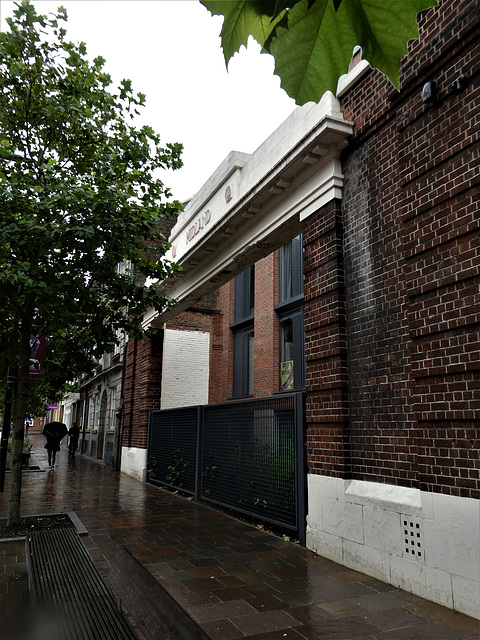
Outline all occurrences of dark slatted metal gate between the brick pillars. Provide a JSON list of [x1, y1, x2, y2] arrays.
[[147, 393, 306, 544]]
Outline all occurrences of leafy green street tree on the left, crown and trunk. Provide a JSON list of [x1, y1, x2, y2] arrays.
[[0, 0, 182, 521]]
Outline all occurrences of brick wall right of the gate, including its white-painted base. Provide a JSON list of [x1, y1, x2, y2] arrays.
[[304, 2, 480, 617]]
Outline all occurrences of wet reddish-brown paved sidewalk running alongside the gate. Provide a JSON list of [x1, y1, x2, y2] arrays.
[[0, 435, 480, 640]]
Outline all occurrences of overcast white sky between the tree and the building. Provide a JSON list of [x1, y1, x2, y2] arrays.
[[0, 0, 295, 200]]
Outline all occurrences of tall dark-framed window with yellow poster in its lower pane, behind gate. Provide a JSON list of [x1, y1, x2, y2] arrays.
[[275, 235, 305, 391]]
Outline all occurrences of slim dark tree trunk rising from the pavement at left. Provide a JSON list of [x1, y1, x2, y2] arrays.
[[7, 322, 30, 525]]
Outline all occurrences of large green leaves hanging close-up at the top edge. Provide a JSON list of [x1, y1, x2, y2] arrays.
[[201, 0, 436, 105]]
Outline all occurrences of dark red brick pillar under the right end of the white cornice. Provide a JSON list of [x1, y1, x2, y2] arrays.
[[303, 201, 350, 478]]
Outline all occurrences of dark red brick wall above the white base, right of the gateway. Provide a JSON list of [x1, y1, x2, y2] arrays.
[[320, 0, 480, 497]]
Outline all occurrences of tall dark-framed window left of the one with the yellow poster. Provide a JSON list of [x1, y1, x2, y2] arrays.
[[230, 266, 255, 398]]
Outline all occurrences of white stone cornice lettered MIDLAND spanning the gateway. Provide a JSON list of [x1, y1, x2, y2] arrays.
[[143, 92, 352, 328]]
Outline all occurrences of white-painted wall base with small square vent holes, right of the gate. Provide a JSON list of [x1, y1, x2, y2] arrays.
[[307, 475, 480, 618]]
